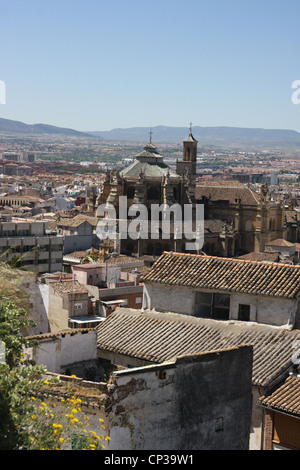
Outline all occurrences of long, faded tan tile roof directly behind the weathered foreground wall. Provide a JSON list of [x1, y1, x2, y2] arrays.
[[97, 308, 300, 387]]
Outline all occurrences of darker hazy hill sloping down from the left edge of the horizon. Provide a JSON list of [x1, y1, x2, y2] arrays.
[[0, 118, 91, 137]]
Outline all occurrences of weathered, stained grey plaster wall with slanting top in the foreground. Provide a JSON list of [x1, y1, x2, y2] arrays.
[[109, 346, 252, 450]]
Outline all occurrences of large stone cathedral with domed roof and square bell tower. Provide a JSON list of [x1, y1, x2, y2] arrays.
[[90, 127, 285, 257]]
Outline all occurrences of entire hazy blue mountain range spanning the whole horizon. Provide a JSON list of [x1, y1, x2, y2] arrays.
[[0, 118, 300, 151]]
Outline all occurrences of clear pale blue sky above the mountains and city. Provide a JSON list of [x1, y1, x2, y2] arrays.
[[0, 0, 300, 131]]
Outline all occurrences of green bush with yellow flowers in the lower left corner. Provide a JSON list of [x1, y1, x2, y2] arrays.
[[0, 302, 109, 450]]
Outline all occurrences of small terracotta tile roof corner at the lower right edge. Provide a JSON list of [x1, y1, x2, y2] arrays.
[[259, 375, 300, 416]]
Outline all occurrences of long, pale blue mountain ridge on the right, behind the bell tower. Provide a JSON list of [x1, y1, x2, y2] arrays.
[[91, 126, 300, 150]]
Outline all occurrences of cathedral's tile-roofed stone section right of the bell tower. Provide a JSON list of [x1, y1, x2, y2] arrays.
[[196, 181, 286, 256]]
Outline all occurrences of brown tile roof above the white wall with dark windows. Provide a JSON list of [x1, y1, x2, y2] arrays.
[[143, 252, 300, 298]]
